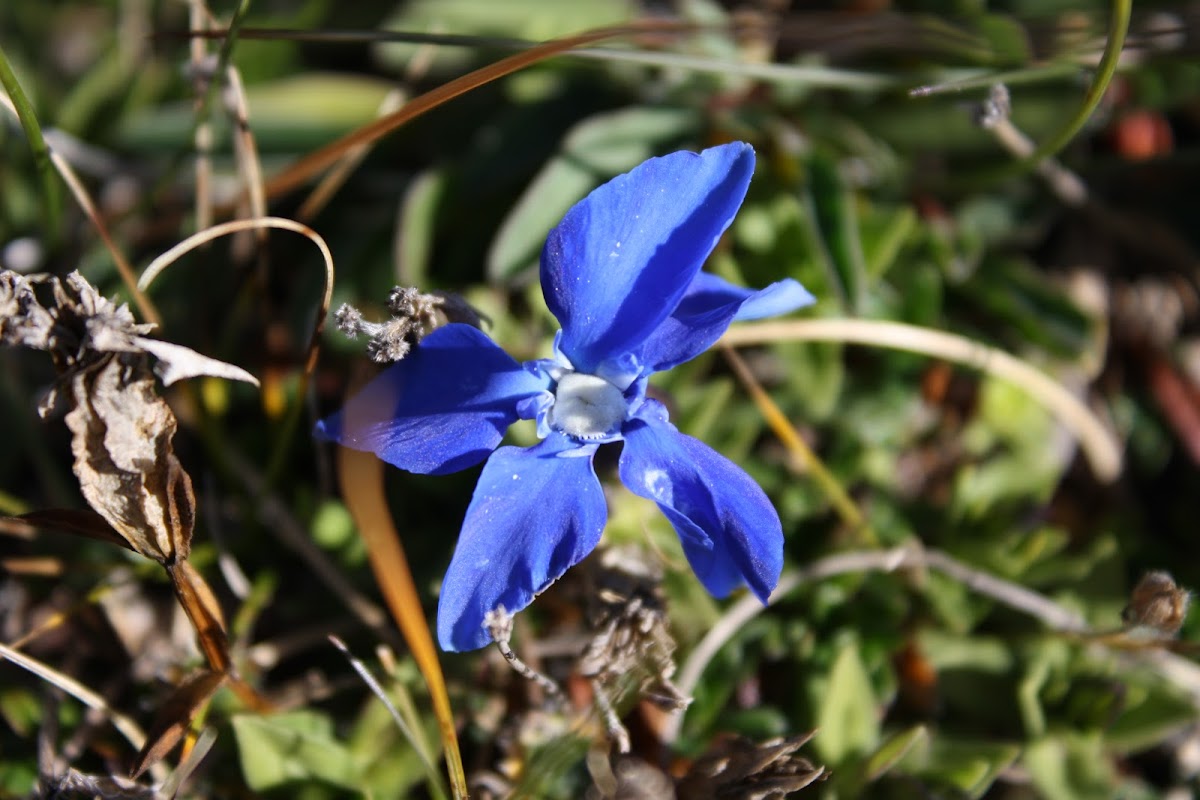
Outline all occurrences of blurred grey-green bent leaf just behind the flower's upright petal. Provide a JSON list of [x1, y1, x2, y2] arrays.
[[487, 107, 698, 282]]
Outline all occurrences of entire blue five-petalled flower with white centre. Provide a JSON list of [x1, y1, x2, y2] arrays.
[[316, 143, 812, 650]]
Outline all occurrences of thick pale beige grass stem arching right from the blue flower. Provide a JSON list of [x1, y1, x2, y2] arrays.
[[720, 319, 1121, 483]]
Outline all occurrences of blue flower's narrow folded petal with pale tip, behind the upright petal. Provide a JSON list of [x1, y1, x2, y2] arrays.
[[642, 272, 815, 372]]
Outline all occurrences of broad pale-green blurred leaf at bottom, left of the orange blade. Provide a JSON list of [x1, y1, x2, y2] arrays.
[[232, 711, 362, 792]]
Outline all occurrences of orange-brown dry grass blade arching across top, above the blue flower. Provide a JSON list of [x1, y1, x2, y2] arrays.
[[266, 22, 694, 197]]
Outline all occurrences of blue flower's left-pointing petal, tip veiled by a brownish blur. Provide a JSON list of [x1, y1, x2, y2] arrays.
[[313, 324, 550, 475]]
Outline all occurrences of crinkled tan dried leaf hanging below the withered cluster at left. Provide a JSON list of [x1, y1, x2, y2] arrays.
[[66, 355, 196, 565]]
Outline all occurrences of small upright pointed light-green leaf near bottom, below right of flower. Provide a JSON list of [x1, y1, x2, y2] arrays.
[[814, 644, 880, 764]]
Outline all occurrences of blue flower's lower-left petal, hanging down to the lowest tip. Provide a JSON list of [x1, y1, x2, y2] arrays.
[[438, 433, 607, 650]]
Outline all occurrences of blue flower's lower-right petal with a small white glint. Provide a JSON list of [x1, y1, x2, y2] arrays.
[[620, 401, 784, 602]]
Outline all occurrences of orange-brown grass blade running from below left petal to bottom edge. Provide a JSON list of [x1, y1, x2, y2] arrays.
[[337, 447, 467, 798]]
